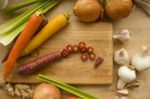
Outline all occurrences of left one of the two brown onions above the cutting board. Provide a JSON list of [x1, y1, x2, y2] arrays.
[[74, 0, 104, 22]]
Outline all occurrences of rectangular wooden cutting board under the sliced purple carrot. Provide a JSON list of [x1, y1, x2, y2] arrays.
[[0, 0, 113, 84]]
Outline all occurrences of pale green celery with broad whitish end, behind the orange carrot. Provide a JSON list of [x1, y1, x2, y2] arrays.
[[0, 0, 61, 46]]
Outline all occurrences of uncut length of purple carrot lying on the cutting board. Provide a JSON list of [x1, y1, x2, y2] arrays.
[[18, 51, 63, 75]]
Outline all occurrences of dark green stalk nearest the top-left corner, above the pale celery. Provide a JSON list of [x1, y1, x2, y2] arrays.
[[4, 0, 44, 15]]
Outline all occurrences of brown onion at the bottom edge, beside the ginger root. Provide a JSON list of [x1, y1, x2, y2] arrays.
[[33, 83, 62, 99]]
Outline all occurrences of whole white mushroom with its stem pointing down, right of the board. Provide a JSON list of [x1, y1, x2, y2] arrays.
[[117, 66, 136, 89]]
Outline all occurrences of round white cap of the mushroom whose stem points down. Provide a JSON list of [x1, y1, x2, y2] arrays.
[[118, 66, 136, 83]]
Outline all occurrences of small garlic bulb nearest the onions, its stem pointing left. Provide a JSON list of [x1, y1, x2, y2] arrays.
[[113, 29, 131, 43]]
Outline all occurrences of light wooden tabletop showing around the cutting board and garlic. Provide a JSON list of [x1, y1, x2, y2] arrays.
[[0, 0, 150, 99]]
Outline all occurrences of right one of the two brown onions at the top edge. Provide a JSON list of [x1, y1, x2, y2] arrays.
[[105, 0, 133, 20]]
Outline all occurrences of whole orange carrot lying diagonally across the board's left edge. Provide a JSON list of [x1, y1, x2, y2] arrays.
[[3, 12, 43, 79]]
